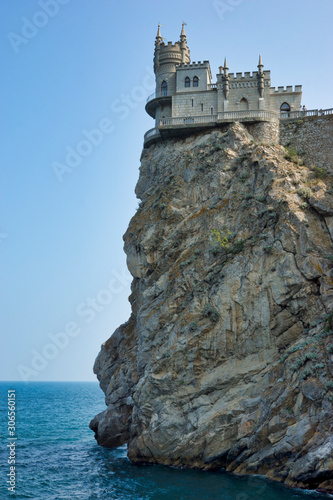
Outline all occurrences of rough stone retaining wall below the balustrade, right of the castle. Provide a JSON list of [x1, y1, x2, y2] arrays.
[[280, 115, 333, 174]]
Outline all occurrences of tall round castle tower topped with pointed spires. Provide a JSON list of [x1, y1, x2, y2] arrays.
[[146, 23, 191, 123]]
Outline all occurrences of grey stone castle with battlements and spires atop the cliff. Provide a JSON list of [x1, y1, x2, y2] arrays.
[[144, 23, 302, 147]]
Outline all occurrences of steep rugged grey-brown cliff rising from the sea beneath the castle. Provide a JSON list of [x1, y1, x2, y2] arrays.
[[90, 124, 333, 491]]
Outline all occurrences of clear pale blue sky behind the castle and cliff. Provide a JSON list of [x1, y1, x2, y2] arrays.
[[0, 0, 333, 381]]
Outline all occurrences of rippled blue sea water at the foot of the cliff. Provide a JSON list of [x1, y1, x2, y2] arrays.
[[0, 382, 329, 500]]
